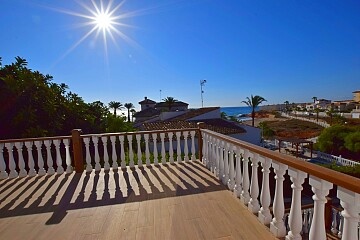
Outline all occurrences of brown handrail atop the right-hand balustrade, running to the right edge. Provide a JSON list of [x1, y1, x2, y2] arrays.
[[201, 129, 360, 193]]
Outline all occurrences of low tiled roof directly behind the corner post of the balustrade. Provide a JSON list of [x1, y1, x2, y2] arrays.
[[140, 118, 246, 134]]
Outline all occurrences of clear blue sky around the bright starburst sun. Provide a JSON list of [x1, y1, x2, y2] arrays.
[[0, 0, 360, 108]]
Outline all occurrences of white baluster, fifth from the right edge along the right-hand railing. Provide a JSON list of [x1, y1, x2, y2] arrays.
[[258, 157, 272, 225]]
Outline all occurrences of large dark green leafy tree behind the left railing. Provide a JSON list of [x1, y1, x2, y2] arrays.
[[0, 57, 132, 139]]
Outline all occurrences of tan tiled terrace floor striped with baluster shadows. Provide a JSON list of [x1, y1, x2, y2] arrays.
[[0, 162, 274, 240]]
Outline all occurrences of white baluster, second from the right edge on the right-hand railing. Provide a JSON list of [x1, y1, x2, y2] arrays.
[[309, 176, 334, 239]]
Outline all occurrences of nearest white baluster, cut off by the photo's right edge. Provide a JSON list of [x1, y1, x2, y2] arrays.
[[337, 187, 360, 240]]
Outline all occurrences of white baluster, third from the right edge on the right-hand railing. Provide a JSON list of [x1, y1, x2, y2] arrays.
[[286, 168, 307, 240]]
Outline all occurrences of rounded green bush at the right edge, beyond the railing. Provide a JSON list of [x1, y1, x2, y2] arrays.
[[316, 125, 360, 159]]
